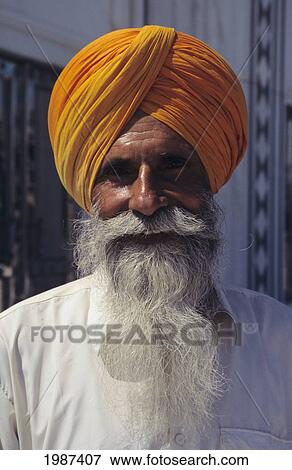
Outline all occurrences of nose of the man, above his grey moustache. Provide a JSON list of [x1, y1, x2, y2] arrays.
[[129, 164, 168, 216]]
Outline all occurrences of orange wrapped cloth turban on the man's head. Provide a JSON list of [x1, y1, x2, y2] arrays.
[[48, 25, 247, 212]]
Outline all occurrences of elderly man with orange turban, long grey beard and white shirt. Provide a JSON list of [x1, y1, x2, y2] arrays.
[[0, 26, 292, 449]]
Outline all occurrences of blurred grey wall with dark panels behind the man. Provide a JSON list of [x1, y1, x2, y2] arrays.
[[0, 0, 292, 310]]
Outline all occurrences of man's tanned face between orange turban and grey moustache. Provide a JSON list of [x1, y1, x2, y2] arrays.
[[92, 110, 209, 219]]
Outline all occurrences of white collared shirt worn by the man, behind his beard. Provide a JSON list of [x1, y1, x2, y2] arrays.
[[0, 277, 292, 449]]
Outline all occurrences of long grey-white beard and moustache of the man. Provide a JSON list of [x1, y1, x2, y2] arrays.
[[74, 194, 225, 449]]
